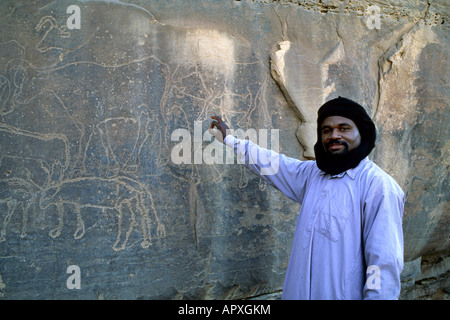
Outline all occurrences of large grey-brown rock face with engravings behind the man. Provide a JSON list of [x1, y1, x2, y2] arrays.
[[0, 0, 450, 299]]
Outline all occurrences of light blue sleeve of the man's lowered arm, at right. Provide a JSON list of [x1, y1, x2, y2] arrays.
[[363, 176, 405, 300]]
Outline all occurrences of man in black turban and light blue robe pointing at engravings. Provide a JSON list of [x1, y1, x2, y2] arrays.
[[210, 97, 405, 299]]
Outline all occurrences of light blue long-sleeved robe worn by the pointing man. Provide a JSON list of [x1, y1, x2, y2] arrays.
[[225, 135, 405, 300]]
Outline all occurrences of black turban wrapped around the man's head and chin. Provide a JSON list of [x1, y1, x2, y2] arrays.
[[314, 97, 377, 175]]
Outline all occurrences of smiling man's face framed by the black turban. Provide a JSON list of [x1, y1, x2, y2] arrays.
[[321, 116, 361, 155]]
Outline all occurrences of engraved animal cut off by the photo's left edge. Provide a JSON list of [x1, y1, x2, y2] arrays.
[[0, 123, 69, 242]]
